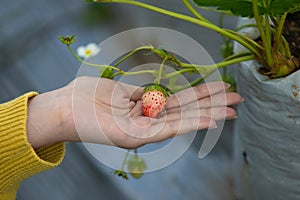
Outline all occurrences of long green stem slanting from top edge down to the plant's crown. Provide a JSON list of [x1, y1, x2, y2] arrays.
[[96, 0, 260, 56]]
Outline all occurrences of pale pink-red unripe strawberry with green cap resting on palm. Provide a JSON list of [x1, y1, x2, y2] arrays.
[[142, 84, 168, 118]]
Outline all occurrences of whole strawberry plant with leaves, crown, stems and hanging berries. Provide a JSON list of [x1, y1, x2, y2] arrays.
[[60, 0, 300, 184]]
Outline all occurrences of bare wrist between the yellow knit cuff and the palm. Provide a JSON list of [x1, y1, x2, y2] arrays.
[[27, 87, 72, 149]]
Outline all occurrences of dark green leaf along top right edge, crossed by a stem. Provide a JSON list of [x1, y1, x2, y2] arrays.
[[193, 0, 300, 17]]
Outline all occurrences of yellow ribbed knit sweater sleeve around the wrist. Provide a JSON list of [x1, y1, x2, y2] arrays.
[[0, 92, 65, 200]]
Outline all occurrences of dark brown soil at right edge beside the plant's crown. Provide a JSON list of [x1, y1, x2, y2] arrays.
[[283, 12, 300, 63]]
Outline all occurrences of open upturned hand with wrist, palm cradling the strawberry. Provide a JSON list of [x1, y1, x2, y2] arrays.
[[29, 77, 242, 148]]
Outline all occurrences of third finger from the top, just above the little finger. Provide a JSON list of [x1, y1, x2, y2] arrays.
[[162, 107, 237, 121]]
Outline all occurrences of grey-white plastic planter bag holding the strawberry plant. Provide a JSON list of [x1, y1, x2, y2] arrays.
[[234, 61, 300, 200]]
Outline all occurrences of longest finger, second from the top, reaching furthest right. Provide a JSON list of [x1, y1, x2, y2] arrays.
[[167, 93, 243, 113]]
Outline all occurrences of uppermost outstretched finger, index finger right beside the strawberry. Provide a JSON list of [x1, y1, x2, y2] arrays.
[[166, 82, 229, 109]]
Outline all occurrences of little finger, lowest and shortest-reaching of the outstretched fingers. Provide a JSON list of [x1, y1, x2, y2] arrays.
[[146, 118, 217, 143]]
